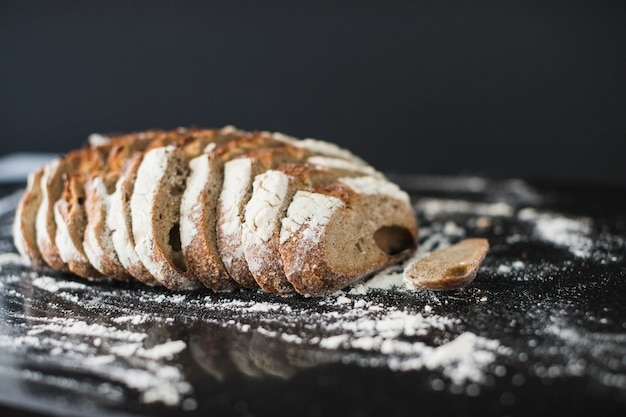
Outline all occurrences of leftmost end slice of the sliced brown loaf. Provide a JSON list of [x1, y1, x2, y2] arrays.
[[13, 168, 46, 268]]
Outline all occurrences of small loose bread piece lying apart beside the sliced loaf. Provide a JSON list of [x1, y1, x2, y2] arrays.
[[404, 238, 489, 290]]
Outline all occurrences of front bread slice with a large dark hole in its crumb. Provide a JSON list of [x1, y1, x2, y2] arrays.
[[279, 176, 417, 296]]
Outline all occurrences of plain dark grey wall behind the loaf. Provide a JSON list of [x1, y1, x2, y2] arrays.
[[0, 0, 626, 184]]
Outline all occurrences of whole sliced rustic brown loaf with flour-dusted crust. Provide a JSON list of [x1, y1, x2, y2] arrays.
[[14, 127, 417, 296]]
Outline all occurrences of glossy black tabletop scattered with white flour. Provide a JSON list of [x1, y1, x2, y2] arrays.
[[0, 176, 626, 416]]
